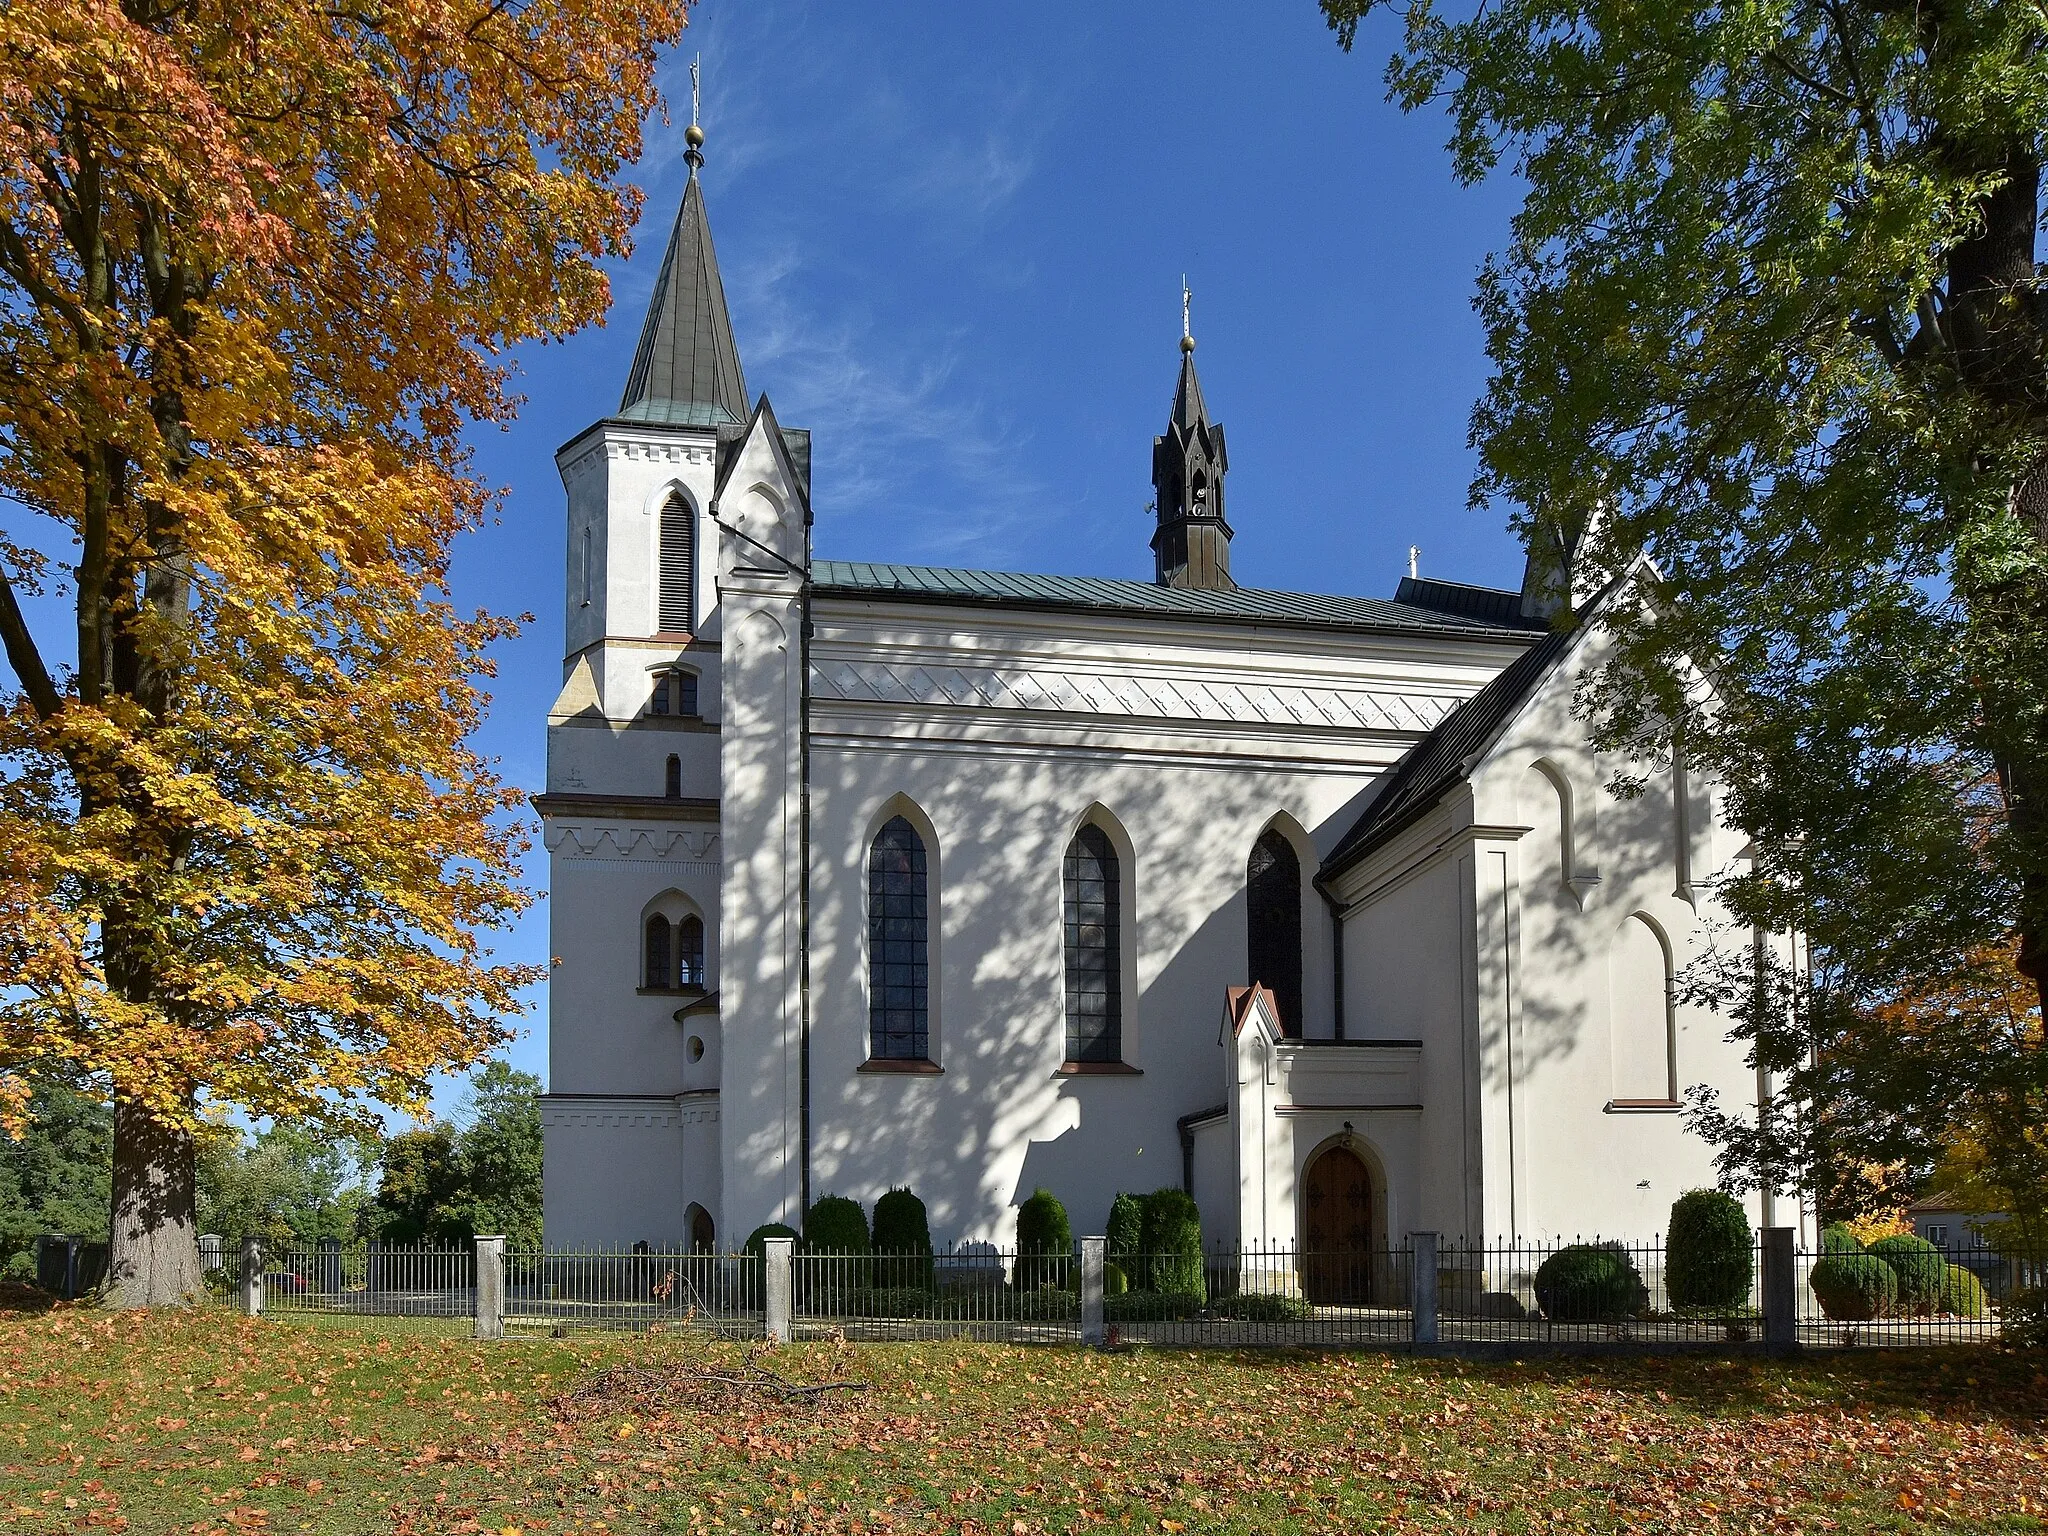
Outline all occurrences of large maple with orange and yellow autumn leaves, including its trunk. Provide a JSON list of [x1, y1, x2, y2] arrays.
[[0, 0, 688, 1305]]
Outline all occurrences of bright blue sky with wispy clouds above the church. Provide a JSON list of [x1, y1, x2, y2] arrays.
[[442, 0, 1522, 1102]]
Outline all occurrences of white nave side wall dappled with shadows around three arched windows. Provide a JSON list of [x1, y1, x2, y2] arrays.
[[790, 598, 1520, 1241]]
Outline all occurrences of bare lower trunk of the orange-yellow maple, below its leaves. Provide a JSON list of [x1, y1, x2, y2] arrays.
[[106, 1098, 205, 1307]]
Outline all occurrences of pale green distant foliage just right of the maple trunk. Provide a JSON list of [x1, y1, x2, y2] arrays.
[[197, 1124, 369, 1247]]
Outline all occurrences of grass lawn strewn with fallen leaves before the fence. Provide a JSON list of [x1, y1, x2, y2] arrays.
[[0, 1309, 2048, 1536]]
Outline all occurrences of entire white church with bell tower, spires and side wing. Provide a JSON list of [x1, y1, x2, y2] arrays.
[[537, 129, 1763, 1249]]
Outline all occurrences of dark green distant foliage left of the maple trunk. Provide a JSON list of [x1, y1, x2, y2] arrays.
[[0, 1075, 113, 1278]]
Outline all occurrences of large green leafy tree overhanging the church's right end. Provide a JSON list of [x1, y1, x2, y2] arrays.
[[1321, 0, 2048, 1212]]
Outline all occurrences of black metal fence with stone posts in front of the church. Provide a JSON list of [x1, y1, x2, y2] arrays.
[[229, 1235, 2048, 1350]]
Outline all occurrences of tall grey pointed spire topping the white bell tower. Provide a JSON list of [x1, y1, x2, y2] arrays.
[[618, 87, 748, 426]]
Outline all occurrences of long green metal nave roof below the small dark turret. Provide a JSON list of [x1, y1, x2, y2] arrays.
[[811, 559, 1536, 639]]
